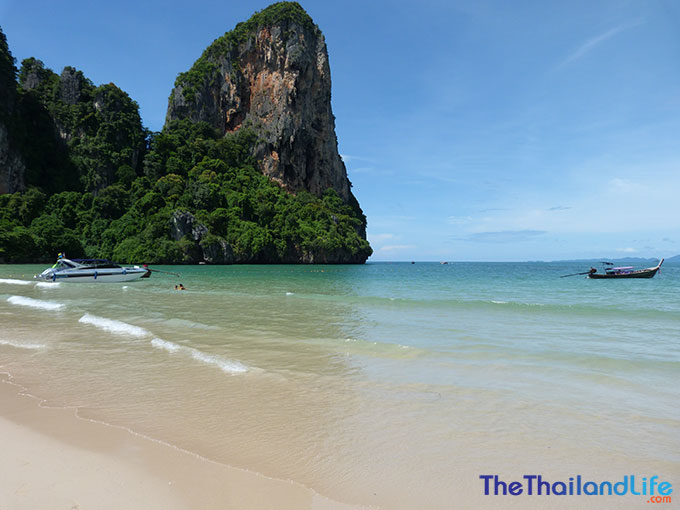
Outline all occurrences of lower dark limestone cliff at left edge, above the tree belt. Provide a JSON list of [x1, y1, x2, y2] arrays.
[[0, 30, 146, 194]]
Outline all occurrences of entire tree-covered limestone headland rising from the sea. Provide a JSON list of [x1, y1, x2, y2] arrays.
[[0, 2, 372, 264]]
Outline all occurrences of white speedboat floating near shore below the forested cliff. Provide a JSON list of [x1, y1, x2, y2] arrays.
[[34, 257, 151, 282]]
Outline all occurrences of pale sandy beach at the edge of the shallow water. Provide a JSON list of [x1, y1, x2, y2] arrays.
[[0, 372, 361, 510]]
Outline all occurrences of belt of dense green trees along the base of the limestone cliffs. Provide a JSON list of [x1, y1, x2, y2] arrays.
[[0, 120, 370, 263]]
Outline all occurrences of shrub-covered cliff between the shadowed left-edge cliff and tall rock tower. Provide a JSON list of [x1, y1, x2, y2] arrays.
[[19, 58, 147, 191]]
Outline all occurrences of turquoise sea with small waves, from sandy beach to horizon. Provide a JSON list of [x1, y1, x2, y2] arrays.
[[0, 263, 680, 508]]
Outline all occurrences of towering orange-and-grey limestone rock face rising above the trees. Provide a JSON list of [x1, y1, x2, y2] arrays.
[[166, 2, 355, 202]]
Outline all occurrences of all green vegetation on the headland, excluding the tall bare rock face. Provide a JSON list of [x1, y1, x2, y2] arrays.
[[0, 17, 371, 263]]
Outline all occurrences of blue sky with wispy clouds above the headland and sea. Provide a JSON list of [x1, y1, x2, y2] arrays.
[[0, 0, 680, 261]]
